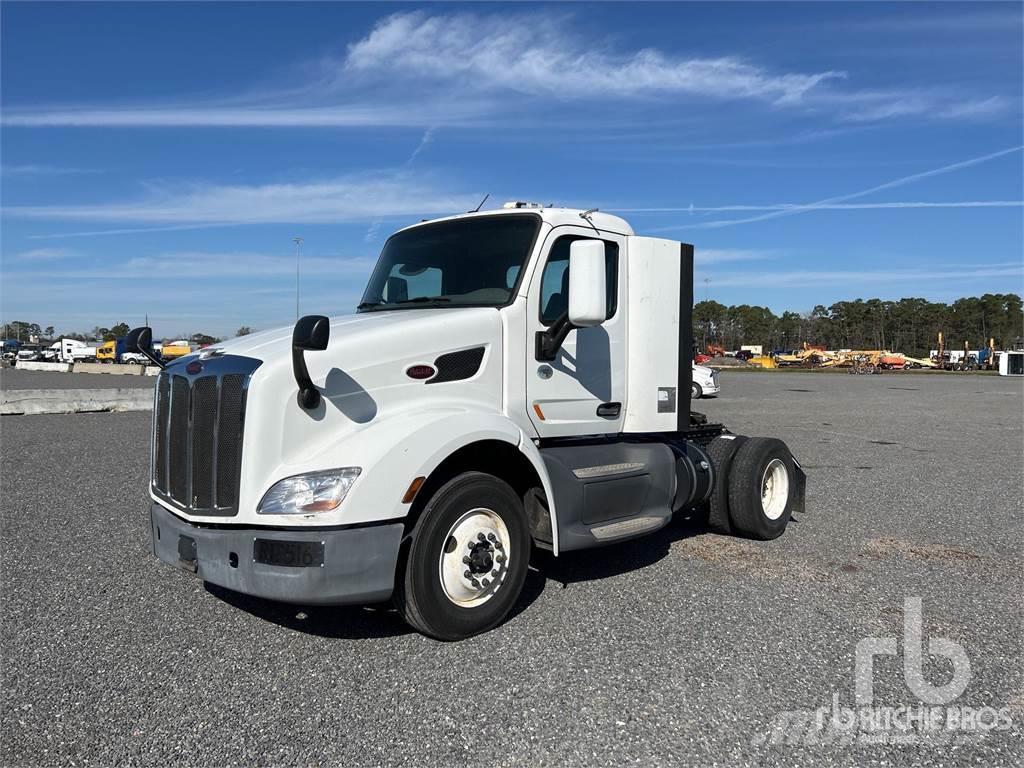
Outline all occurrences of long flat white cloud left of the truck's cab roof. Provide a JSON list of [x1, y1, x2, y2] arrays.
[[4, 172, 479, 225]]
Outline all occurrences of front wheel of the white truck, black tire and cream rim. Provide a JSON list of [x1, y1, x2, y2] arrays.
[[394, 472, 530, 640]]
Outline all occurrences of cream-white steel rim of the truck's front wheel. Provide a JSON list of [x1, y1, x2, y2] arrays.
[[438, 507, 513, 608]]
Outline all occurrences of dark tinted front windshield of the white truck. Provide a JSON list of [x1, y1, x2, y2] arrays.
[[358, 214, 541, 311]]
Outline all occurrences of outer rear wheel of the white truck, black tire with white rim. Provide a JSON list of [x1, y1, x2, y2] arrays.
[[729, 437, 797, 540]]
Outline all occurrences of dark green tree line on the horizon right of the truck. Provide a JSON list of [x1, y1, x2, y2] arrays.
[[693, 293, 1024, 357]]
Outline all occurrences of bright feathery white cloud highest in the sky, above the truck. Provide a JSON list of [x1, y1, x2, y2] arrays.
[[344, 11, 845, 103]]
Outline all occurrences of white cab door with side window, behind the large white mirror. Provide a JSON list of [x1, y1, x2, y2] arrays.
[[526, 226, 626, 437]]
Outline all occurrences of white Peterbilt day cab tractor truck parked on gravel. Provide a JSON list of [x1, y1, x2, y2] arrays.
[[129, 203, 805, 640]]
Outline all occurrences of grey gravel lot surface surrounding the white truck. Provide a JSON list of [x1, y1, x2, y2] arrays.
[[0, 372, 1024, 766]]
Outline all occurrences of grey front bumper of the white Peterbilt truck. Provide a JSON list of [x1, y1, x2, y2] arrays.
[[150, 502, 403, 605]]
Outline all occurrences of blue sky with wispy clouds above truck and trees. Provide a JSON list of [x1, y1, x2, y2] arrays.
[[0, 3, 1024, 335]]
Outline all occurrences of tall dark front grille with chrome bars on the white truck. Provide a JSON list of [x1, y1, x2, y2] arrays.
[[152, 355, 260, 517]]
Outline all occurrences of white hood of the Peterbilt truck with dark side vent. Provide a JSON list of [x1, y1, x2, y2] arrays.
[[209, 307, 503, 506]]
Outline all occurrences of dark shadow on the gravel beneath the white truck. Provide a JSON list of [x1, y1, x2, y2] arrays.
[[204, 514, 720, 640]]
